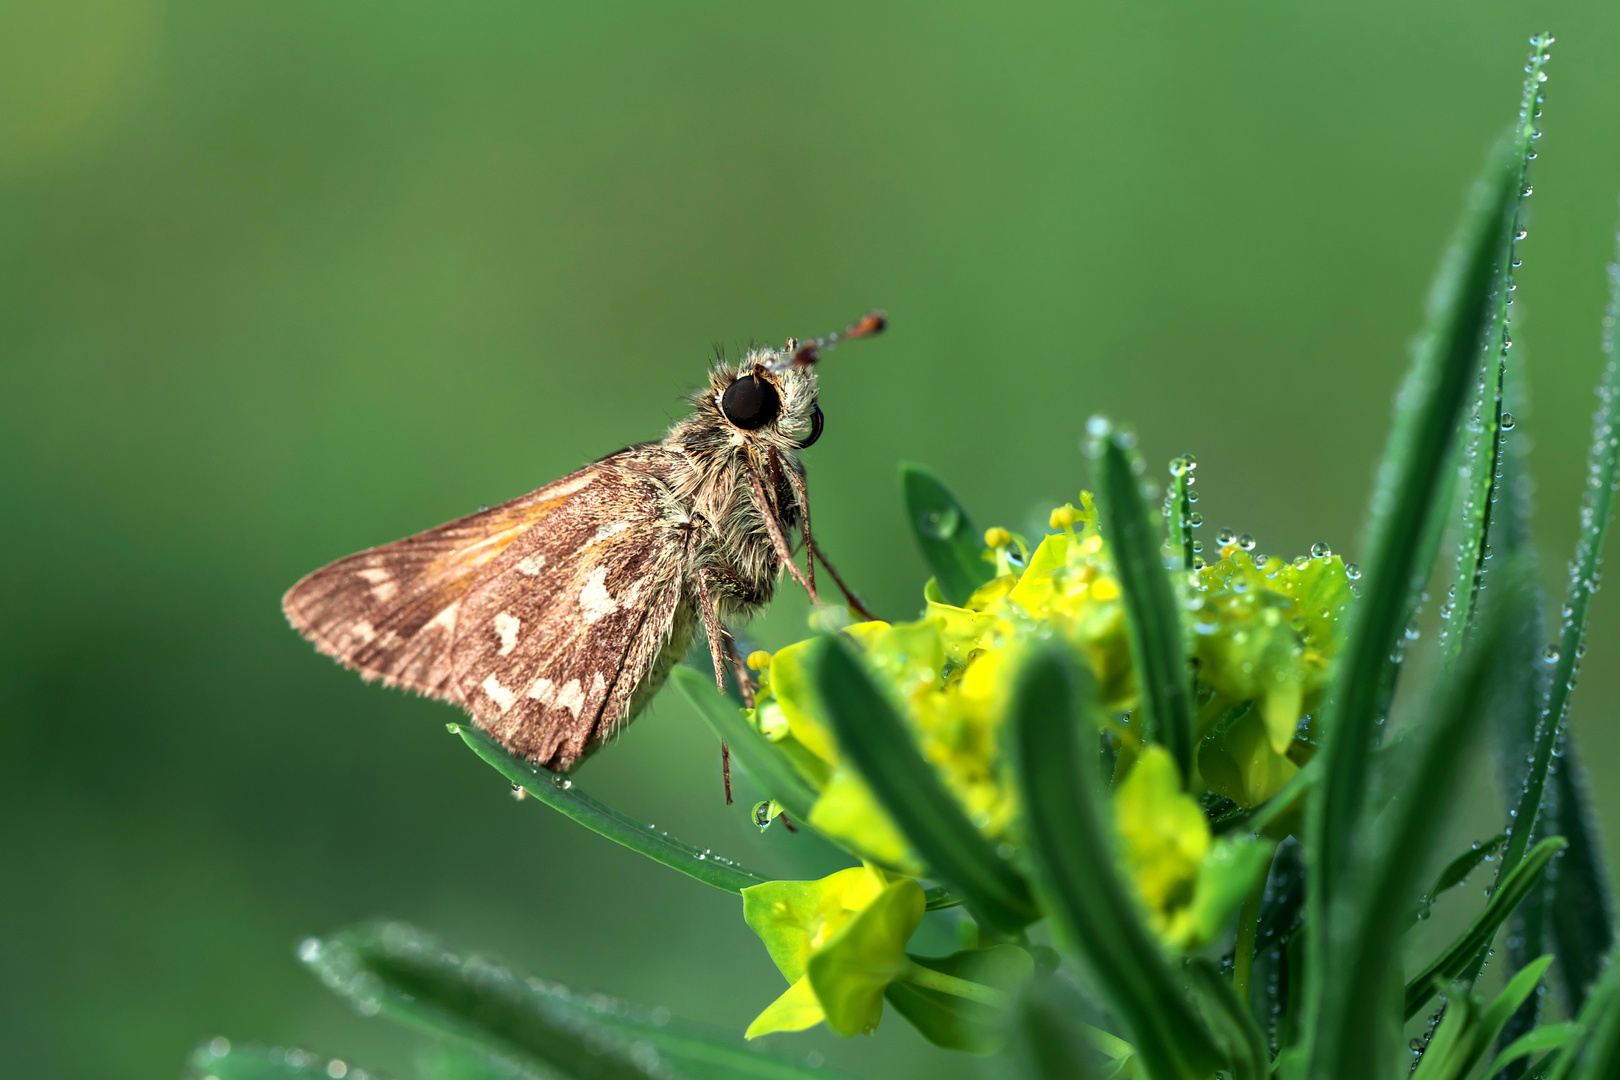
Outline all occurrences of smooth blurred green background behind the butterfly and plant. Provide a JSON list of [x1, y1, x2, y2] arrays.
[[0, 0, 1620, 1080]]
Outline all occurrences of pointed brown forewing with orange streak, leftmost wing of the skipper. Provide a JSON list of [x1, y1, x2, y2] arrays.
[[282, 466, 598, 701]]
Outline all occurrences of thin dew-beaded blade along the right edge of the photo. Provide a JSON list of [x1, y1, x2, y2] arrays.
[[1497, 215, 1620, 984]]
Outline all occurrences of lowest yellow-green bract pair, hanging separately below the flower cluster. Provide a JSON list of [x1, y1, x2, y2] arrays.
[[742, 866, 925, 1038]]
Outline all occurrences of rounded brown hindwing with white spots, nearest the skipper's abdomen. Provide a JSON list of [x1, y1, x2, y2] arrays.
[[452, 450, 690, 771]]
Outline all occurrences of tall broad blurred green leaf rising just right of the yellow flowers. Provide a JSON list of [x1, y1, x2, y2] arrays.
[[1307, 131, 1520, 1049]]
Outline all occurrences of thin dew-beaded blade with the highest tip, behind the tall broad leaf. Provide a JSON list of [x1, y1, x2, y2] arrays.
[[1440, 34, 1552, 670]]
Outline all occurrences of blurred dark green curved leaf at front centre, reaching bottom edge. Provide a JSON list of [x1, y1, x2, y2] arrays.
[[1011, 648, 1225, 1080]]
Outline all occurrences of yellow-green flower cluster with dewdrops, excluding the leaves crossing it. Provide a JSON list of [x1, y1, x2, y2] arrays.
[[747, 492, 1351, 1035]]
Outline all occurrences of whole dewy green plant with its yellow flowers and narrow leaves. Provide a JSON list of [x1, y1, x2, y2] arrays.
[[202, 37, 1620, 1080]]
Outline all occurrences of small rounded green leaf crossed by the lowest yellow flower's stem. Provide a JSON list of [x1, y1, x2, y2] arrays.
[[886, 946, 1035, 1054]]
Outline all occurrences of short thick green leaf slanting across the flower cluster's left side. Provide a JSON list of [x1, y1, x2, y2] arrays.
[[808, 638, 1038, 934]]
